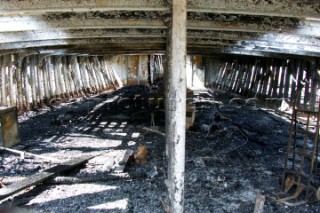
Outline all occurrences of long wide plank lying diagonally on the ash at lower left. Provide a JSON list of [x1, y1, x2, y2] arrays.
[[0, 155, 95, 199]]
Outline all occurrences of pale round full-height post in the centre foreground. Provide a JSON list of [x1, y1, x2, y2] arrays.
[[166, 0, 187, 213]]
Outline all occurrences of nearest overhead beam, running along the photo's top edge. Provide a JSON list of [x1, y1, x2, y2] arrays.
[[0, 0, 320, 18]]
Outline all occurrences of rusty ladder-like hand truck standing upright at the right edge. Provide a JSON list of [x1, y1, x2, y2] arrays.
[[278, 79, 320, 206]]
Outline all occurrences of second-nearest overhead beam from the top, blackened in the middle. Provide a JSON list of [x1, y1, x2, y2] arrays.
[[0, 11, 320, 35]]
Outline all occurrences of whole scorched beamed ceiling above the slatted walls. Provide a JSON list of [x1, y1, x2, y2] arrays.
[[0, 0, 320, 57]]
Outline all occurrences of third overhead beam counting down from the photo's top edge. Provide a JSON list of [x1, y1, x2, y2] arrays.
[[0, 29, 320, 48]]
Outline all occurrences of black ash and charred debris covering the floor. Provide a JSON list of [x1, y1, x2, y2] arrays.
[[0, 86, 320, 213]]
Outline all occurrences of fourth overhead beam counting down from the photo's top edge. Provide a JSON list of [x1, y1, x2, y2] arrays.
[[0, 36, 320, 57]]
